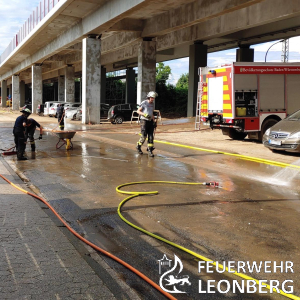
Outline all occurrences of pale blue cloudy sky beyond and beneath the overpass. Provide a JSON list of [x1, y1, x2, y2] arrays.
[[0, 0, 300, 85]]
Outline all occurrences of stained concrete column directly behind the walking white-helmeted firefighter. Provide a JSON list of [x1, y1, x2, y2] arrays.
[[137, 41, 156, 104]]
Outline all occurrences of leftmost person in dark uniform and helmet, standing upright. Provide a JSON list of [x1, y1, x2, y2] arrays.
[[13, 108, 31, 160]]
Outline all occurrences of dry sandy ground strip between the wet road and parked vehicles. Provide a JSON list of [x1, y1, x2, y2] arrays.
[[0, 108, 300, 164]]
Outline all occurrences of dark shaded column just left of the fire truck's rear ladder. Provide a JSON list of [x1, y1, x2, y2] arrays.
[[187, 42, 207, 117]]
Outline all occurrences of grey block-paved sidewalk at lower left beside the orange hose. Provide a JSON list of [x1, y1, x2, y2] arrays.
[[0, 157, 138, 300]]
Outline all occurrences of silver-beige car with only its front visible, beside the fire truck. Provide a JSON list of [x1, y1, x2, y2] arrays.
[[262, 110, 300, 152]]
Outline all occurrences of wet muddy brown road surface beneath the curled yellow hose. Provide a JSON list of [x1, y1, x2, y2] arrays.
[[0, 118, 300, 299]]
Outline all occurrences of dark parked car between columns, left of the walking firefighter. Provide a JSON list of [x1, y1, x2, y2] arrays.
[[107, 103, 139, 124]]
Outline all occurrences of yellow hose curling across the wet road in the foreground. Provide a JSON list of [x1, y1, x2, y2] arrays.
[[116, 181, 300, 300]]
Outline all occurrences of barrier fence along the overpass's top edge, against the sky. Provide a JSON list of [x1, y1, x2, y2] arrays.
[[0, 0, 59, 66]]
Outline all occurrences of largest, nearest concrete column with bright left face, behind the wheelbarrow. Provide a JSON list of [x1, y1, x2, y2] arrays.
[[82, 38, 101, 124]]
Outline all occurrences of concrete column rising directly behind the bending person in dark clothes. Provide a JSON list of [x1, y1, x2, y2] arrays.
[[31, 66, 43, 112]]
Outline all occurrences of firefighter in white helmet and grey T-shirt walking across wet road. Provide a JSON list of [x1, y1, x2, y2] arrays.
[[136, 91, 158, 157]]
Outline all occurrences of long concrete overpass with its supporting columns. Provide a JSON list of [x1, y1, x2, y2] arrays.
[[0, 0, 300, 123]]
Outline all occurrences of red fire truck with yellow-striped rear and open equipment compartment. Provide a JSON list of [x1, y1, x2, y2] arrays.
[[196, 62, 300, 141]]
